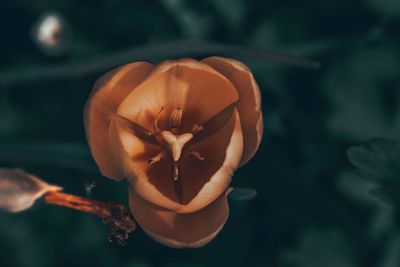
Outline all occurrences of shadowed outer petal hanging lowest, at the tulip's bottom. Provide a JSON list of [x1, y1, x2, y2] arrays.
[[129, 186, 230, 248]]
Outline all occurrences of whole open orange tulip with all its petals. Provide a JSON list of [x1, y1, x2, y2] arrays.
[[85, 57, 263, 247]]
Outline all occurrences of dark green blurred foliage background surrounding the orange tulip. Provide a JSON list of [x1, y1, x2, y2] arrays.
[[0, 0, 400, 267]]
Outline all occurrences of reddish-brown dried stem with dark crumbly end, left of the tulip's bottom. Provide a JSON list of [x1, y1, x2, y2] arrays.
[[43, 192, 136, 246]]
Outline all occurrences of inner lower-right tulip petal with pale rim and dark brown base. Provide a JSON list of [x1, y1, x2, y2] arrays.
[[177, 109, 243, 213]]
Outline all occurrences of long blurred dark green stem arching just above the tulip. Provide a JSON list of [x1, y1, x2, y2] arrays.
[[0, 40, 319, 86]]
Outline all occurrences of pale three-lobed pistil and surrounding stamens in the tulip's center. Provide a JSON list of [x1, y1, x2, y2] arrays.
[[148, 107, 205, 181]]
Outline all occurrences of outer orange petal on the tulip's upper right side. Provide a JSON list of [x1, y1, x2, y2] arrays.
[[202, 57, 263, 165]]
